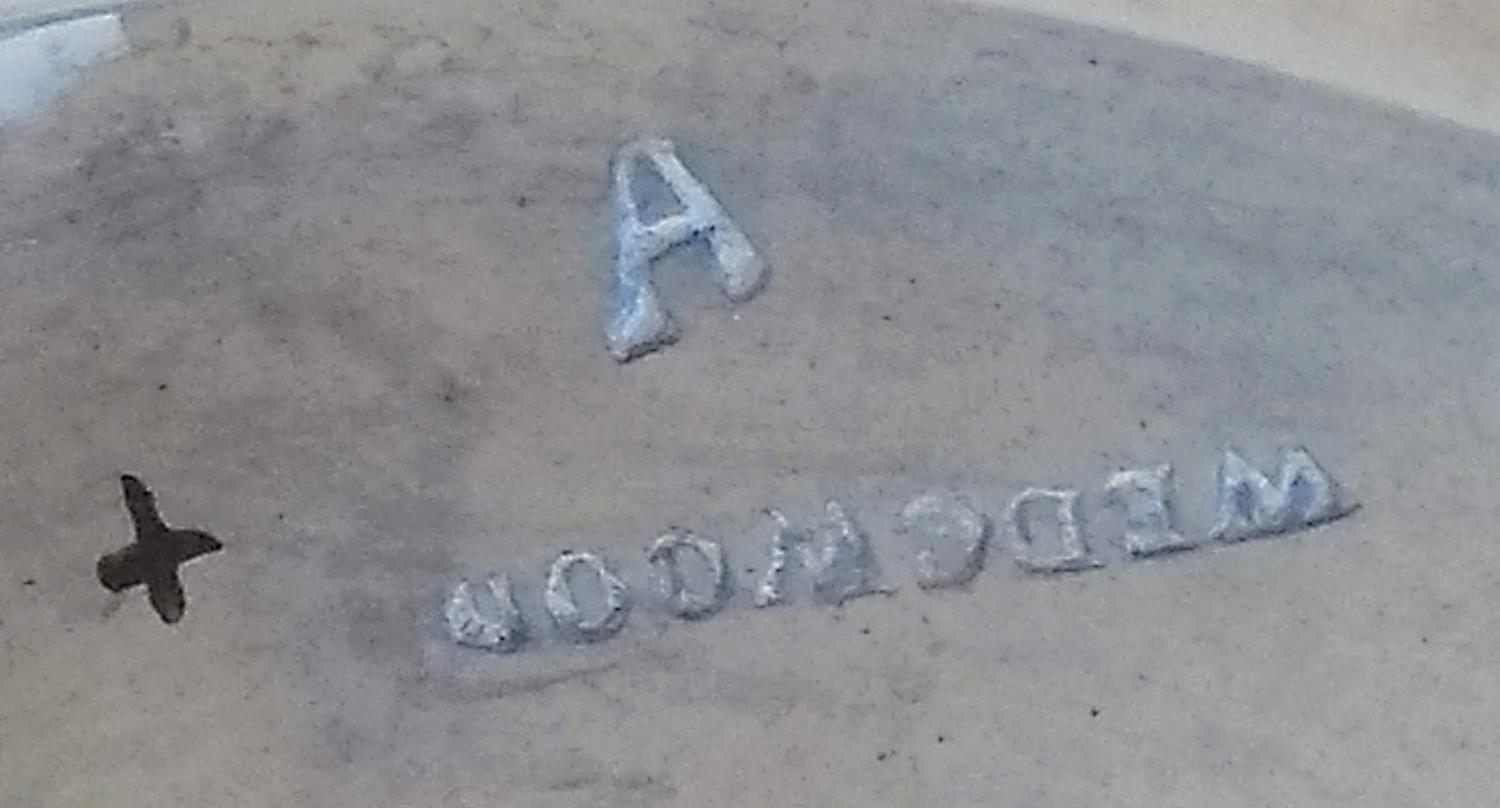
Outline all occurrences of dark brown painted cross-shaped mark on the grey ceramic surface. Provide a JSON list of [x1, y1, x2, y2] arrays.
[[99, 474, 224, 624]]
